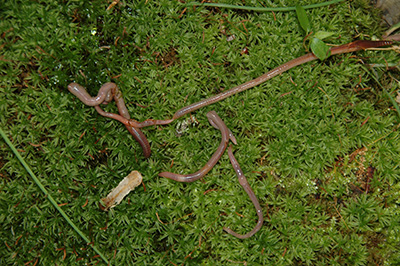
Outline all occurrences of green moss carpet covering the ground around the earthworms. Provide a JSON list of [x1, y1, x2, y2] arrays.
[[0, 0, 400, 265]]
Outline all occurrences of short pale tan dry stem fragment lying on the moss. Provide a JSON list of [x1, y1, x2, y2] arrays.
[[101, 171, 143, 211]]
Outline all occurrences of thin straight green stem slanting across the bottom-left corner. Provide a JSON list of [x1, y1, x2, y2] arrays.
[[0, 128, 110, 265]]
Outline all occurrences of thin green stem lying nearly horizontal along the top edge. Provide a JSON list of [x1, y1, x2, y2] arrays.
[[185, 0, 344, 12]]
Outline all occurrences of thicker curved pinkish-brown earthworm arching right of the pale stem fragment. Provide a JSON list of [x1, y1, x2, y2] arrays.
[[158, 111, 237, 182]]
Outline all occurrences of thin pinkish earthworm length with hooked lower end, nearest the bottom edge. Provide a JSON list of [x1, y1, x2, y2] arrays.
[[224, 145, 264, 239]]
